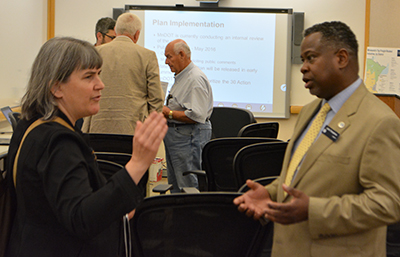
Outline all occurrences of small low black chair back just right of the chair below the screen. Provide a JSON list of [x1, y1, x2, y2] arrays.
[[238, 122, 279, 138]]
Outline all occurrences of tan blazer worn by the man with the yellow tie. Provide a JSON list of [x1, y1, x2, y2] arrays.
[[267, 85, 400, 257]]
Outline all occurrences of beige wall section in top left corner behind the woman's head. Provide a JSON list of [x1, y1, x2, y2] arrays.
[[0, 0, 47, 107]]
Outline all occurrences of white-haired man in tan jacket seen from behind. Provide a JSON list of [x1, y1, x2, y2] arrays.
[[82, 13, 164, 135]]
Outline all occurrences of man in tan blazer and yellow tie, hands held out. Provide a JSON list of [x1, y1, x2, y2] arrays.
[[234, 22, 400, 257]]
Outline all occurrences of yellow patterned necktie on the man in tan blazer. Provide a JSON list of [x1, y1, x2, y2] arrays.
[[285, 103, 331, 186]]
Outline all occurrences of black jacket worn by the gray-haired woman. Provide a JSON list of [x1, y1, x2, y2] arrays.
[[8, 112, 143, 257]]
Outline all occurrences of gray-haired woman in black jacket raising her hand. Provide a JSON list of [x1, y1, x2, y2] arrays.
[[7, 37, 168, 257]]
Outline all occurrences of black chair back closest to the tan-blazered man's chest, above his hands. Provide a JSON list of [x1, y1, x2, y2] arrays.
[[233, 142, 288, 186]]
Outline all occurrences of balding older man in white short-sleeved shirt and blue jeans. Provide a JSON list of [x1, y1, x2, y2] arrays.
[[162, 39, 214, 193]]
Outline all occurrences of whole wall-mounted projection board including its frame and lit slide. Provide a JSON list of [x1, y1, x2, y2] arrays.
[[130, 5, 292, 118]]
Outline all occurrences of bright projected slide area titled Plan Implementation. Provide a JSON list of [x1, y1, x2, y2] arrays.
[[144, 11, 275, 112]]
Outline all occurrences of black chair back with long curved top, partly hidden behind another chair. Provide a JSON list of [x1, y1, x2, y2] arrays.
[[202, 137, 282, 192]]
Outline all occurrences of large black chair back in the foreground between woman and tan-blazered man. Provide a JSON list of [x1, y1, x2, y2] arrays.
[[132, 193, 272, 257]]
